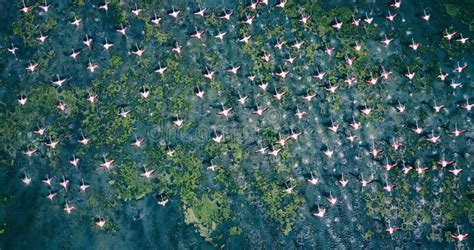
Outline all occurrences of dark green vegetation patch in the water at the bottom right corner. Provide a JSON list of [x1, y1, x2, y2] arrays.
[[365, 173, 474, 241]]
